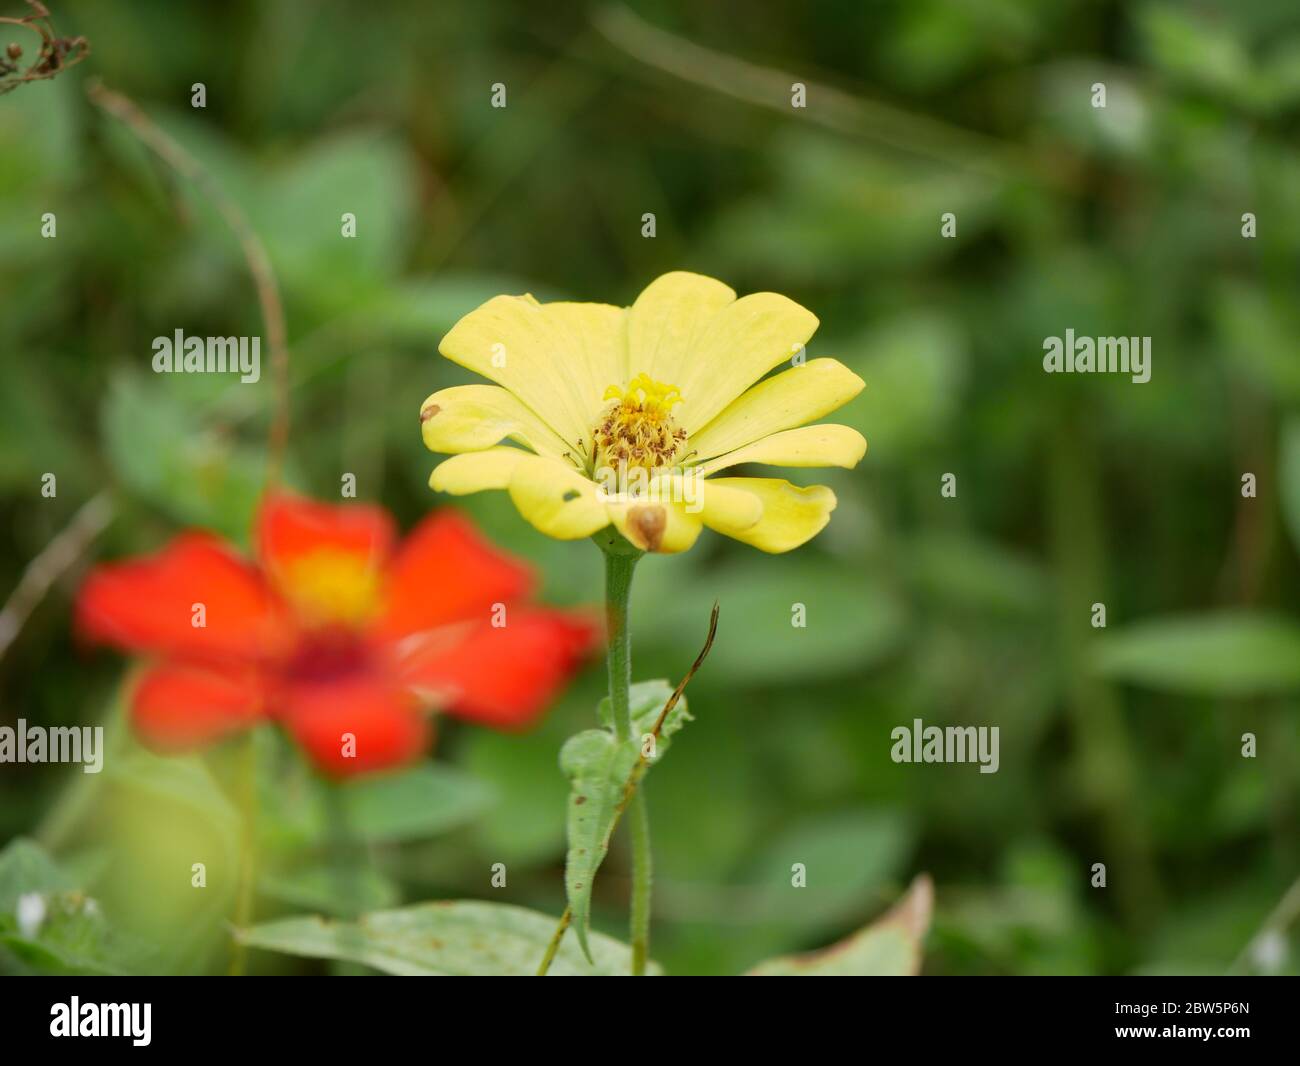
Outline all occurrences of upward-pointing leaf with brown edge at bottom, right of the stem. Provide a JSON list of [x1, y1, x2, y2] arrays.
[[746, 875, 935, 978]]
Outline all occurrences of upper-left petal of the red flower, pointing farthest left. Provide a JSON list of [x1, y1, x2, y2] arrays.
[[77, 533, 286, 660]]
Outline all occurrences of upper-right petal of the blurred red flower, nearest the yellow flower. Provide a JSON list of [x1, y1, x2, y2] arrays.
[[376, 510, 533, 638]]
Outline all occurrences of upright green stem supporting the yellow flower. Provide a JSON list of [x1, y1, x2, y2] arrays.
[[599, 538, 651, 978]]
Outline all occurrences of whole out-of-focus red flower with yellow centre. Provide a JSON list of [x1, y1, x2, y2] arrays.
[[77, 495, 597, 775]]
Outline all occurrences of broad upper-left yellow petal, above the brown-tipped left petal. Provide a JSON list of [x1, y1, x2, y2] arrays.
[[438, 296, 590, 449]]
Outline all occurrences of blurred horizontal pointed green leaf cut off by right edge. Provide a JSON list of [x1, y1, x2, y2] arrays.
[[1095, 611, 1300, 697]]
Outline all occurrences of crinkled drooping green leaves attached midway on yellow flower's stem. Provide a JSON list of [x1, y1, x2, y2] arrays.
[[560, 681, 690, 959]]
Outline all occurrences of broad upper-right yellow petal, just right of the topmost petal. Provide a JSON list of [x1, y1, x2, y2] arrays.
[[676, 293, 818, 434]]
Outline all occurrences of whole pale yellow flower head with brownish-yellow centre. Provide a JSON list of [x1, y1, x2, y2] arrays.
[[420, 272, 867, 551]]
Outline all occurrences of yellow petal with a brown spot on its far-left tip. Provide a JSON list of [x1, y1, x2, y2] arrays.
[[420, 385, 568, 459]]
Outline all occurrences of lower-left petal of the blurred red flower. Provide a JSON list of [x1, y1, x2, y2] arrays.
[[131, 663, 263, 751]]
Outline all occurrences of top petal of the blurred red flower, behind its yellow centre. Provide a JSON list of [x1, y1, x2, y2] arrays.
[[257, 493, 394, 576]]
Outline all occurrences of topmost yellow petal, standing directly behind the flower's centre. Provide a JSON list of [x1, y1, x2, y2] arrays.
[[626, 270, 736, 387]]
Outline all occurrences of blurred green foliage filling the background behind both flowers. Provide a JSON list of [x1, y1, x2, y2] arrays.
[[0, 0, 1300, 974]]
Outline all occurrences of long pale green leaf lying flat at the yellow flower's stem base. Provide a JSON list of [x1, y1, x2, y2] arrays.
[[237, 900, 658, 976]]
